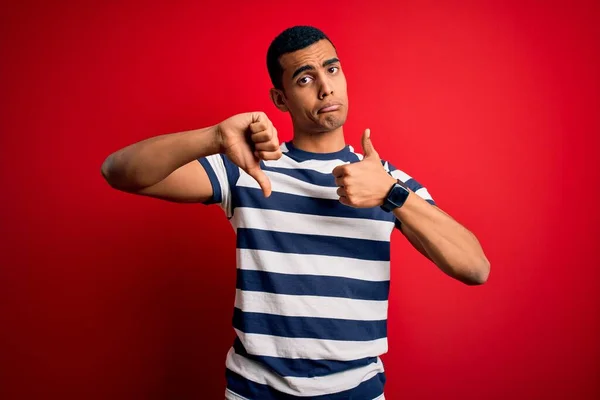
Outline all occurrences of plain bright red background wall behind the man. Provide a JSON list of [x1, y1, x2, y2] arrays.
[[0, 1, 600, 400]]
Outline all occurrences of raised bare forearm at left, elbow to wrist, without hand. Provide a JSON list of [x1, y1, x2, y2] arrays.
[[102, 125, 220, 190]]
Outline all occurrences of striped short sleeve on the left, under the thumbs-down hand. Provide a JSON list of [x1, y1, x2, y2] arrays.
[[198, 154, 240, 218]]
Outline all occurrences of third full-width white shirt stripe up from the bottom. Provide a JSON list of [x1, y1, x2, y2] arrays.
[[235, 289, 388, 321]]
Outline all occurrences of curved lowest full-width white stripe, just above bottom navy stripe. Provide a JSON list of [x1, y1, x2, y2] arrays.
[[226, 348, 384, 396]]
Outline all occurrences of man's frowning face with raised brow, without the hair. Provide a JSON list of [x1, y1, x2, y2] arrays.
[[279, 40, 348, 133]]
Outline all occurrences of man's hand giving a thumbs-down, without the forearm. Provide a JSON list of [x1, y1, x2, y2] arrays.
[[216, 112, 282, 197]]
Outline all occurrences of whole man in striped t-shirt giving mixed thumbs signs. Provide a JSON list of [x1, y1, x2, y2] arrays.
[[102, 26, 490, 400]]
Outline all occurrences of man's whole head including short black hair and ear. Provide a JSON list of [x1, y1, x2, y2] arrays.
[[267, 26, 348, 133]]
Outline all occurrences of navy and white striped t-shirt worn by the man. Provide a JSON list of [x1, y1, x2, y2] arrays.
[[199, 142, 434, 400]]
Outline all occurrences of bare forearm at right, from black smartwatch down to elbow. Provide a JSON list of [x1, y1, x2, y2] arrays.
[[394, 192, 489, 284]]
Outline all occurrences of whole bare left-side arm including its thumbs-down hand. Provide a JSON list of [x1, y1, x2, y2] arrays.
[[101, 112, 281, 202]]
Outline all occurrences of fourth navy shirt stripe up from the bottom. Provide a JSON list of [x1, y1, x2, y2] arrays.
[[236, 269, 390, 301]]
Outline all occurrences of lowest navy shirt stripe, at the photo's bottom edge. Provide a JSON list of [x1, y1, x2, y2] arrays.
[[225, 368, 386, 400]]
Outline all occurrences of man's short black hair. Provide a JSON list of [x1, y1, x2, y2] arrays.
[[267, 25, 335, 89]]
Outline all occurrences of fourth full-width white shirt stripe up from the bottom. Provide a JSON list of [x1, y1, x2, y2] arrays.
[[236, 249, 390, 282]]
